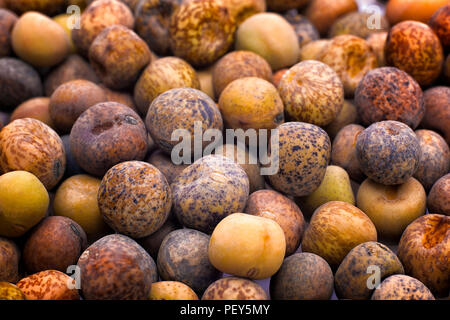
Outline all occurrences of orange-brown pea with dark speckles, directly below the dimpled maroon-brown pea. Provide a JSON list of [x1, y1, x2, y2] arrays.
[[97, 161, 172, 238]]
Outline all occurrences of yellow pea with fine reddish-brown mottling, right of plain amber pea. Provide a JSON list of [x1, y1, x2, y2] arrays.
[[278, 60, 344, 126]]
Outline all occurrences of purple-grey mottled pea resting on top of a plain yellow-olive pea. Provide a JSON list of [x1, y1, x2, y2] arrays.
[[356, 120, 421, 185]]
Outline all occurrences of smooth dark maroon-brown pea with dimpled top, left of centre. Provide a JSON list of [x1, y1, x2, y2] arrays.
[[70, 102, 148, 177]]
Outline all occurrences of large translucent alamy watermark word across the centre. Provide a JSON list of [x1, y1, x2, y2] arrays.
[[171, 121, 279, 175]]
